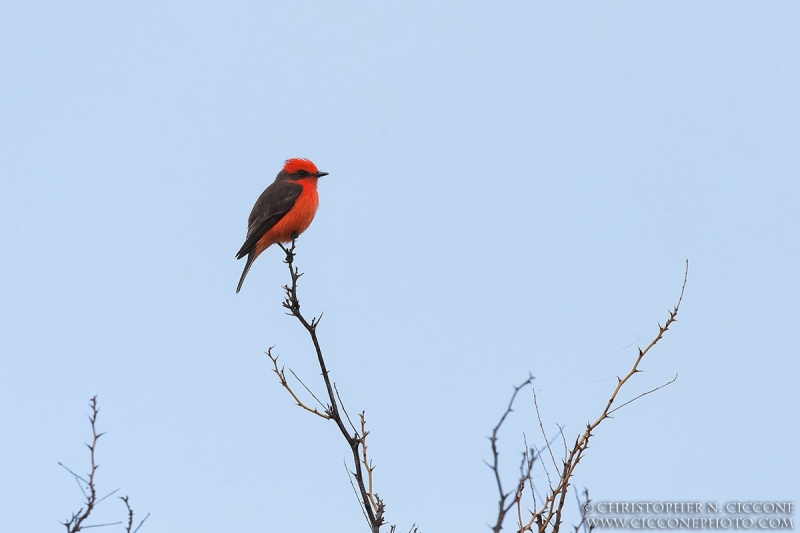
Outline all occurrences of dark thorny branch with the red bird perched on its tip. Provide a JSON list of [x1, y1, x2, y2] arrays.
[[267, 236, 394, 533]]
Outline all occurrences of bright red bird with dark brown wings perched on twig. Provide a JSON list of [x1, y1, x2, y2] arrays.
[[236, 158, 328, 293]]
